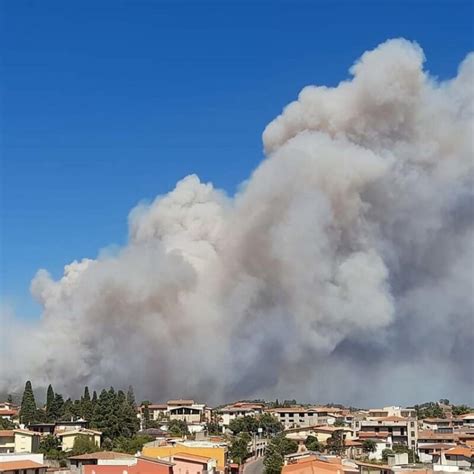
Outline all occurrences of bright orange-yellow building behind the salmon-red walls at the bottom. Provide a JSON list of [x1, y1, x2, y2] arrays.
[[142, 441, 227, 471]]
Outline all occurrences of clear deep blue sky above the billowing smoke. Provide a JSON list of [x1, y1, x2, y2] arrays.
[[0, 0, 474, 317]]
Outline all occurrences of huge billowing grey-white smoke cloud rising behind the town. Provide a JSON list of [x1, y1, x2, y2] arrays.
[[0, 39, 474, 405]]
